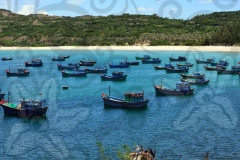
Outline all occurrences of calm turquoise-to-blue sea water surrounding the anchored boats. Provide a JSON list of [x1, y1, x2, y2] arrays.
[[0, 48, 240, 159]]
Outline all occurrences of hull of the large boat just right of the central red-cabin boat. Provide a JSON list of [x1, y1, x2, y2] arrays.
[[154, 86, 194, 96]]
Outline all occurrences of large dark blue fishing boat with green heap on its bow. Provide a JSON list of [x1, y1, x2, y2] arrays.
[[0, 92, 48, 118]]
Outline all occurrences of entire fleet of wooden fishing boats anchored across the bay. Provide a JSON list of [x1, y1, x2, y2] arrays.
[[0, 55, 240, 117]]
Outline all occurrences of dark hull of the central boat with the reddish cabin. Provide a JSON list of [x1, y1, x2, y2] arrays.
[[102, 97, 149, 109]]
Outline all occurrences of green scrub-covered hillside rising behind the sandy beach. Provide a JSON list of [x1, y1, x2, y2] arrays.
[[0, 9, 240, 46]]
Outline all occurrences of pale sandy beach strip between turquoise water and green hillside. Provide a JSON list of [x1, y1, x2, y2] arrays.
[[0, 46, 240, 52]]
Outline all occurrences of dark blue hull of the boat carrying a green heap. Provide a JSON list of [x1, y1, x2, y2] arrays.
[[1, 104, 48, 117]]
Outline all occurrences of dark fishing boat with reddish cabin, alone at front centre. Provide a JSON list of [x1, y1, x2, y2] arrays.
[[102, 87, 149, 109]]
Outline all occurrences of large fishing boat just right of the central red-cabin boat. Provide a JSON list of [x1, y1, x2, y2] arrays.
[[154, 81, 194, 96]]
